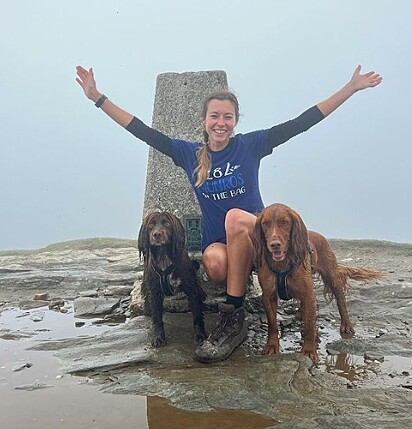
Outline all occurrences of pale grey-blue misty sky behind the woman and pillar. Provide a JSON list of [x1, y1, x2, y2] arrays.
[[0, 0, 412, 249]]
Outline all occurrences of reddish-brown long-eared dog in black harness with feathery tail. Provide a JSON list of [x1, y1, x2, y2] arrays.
[[254, 204, 382, 362]]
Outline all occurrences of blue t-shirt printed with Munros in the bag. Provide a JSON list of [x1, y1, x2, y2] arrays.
[[172, 130, 272, 250]]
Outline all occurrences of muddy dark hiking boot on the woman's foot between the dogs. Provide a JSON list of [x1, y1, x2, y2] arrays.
[[195, 303, 248, 363]]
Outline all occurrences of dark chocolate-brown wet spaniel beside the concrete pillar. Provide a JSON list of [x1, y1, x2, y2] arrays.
[[138, 211, 206, 347]]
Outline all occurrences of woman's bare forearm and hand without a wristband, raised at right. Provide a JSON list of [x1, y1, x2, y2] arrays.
[[317, 66, 382, 116]]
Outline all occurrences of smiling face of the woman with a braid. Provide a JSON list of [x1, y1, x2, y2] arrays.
[[204, 99, 237, 150]]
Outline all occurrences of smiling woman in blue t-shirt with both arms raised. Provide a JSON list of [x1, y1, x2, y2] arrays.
[[76, 66, 382, 363]]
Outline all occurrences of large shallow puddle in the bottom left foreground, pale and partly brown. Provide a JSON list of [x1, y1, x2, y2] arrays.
[[0, 306, 275, 429]]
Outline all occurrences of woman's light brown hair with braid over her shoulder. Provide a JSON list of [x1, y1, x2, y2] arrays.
[[193, 91, 240, 187]]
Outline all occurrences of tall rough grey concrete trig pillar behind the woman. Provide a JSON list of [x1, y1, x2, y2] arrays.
[[143, 71, 228, 251]]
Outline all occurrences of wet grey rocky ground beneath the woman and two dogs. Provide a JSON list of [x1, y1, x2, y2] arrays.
[[0, 240, 412, 429]]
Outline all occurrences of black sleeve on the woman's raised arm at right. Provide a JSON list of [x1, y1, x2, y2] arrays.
[[268, 106, 325, 149]]
